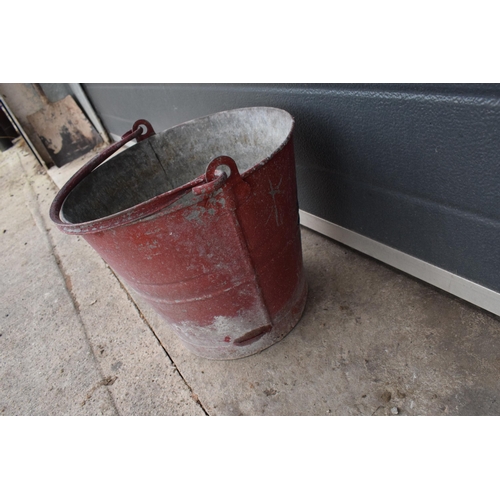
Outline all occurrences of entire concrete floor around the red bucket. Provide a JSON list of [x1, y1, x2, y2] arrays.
[[0, 144, 500, 416]]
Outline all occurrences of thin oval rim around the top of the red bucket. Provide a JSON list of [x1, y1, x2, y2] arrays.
[[53, 106, 295, 235]]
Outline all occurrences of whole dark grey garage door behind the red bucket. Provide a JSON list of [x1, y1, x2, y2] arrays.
[[85, 84, 500, 298]]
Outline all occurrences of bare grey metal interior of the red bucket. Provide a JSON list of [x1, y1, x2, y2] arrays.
[[61, 107, 293, 224]]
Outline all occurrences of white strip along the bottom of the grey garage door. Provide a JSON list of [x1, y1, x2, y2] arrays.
[[299, 210, 500, 316]]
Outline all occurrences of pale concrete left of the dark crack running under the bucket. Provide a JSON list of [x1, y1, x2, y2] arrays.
[[0, 143, 205, 415]]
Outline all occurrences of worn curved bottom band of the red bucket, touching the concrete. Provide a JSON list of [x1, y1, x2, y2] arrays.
[[181, 278, 307, 360]]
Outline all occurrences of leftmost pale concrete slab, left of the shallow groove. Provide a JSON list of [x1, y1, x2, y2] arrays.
[[0, 145, 117, 415]]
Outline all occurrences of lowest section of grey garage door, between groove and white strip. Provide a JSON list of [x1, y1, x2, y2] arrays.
[[299, 168, 500, 291]]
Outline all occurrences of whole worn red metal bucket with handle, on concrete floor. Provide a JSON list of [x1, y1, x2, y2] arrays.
[[51, 107, 307, 359]]
